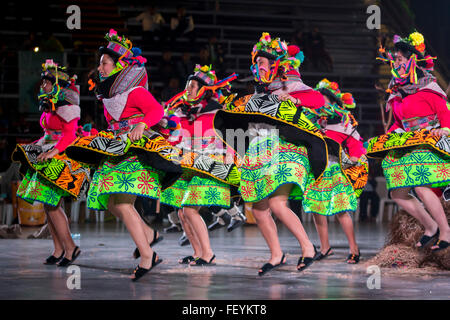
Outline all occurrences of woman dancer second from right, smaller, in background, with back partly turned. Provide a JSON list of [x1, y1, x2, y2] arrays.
[[303, 79, 368, 264]]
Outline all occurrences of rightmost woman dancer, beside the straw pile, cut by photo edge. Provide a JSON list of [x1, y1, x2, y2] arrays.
[[367, 32, 450, 251]]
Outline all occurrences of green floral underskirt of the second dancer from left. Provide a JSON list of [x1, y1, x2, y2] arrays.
[[88, 155, 163, 210]]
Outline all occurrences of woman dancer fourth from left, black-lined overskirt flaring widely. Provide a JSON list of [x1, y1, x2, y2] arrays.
[[214, 33, 327, 276]]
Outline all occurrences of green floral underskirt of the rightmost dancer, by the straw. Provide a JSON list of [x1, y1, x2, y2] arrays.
[[382, 146, 450, 190]]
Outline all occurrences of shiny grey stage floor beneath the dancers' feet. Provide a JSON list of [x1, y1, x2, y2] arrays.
[[0, 222, 450, 300]]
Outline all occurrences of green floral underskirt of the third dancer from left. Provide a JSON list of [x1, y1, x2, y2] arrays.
[[160, 171, 231, 208]]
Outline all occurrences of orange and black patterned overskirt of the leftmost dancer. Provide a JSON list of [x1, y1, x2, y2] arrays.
[[12, 144, 89, 202]]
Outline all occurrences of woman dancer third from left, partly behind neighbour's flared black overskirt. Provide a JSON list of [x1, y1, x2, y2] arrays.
[[161, 65, 240, 266]]
